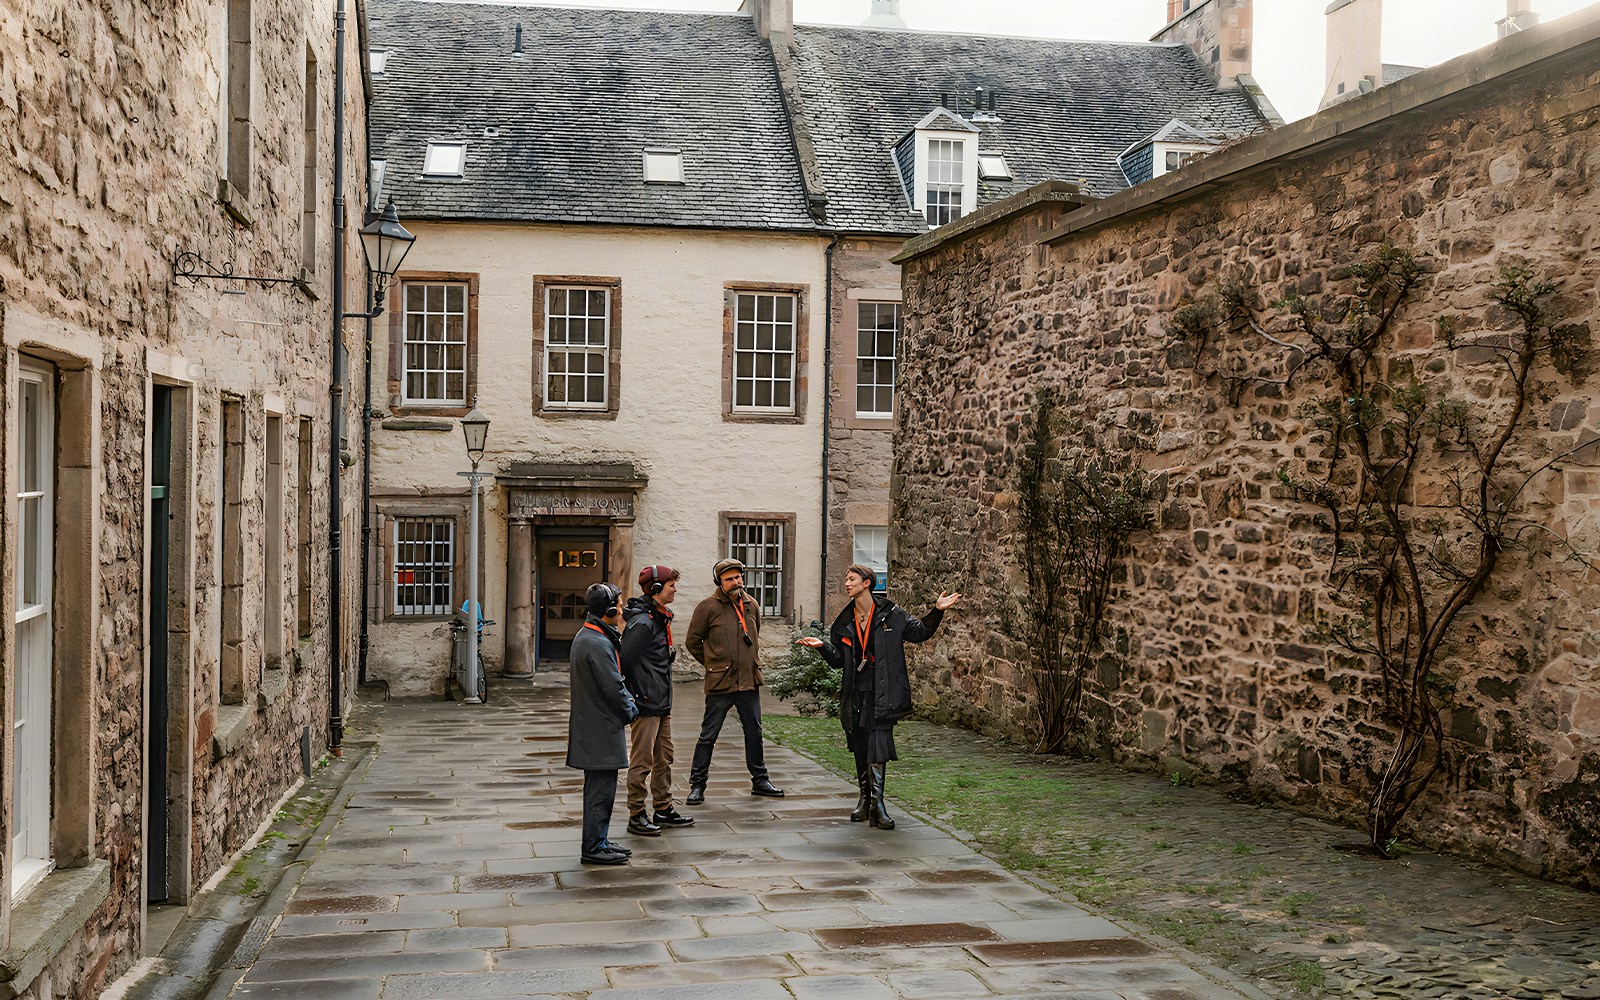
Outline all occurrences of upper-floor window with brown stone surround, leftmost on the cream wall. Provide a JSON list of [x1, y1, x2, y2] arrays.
[[389, 272, 478, 416]]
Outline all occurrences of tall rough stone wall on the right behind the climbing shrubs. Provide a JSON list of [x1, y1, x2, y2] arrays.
[[893, 50, 1600, 885]]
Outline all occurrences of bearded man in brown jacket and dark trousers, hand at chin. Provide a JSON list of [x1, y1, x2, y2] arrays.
[[683, 558, 784, 805]]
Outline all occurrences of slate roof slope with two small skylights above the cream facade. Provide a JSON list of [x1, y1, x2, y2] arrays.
[[366, 0, 814, 230]]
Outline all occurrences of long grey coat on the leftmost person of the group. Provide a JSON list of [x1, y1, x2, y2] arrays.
[[566, 614, 638, 771]]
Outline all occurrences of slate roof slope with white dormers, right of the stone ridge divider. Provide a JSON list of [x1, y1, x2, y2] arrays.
[[794, 24, 1267, 235]]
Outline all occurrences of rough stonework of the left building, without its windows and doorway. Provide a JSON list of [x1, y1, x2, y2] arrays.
[[0, 0, 366, 998]]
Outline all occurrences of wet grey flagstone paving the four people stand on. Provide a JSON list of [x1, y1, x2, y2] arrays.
[[232, 685, 1262, 1000]]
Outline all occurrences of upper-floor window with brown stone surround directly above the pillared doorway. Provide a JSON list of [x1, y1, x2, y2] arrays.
[[533, 275, 622, 419]]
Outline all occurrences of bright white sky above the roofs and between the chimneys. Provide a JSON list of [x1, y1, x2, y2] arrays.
[[448, 0, 1600, 122]]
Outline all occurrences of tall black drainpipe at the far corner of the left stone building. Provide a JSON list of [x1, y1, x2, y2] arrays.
[[328, 0, 344, 757]]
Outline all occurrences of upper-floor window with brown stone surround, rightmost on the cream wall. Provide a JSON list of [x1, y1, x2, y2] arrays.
[[722, 282, 808, 424]]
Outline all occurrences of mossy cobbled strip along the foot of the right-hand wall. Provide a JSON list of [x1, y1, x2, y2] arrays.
[[764, 720, 1600, 1000]]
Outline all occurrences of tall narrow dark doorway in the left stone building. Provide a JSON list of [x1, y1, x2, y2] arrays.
[[144, 386, 173, 902]]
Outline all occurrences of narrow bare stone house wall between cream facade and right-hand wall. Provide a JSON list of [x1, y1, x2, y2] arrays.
[[818, 237, 901, 611]]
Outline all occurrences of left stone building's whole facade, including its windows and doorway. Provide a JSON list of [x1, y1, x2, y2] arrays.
[[0, 0, 366, 998]]
